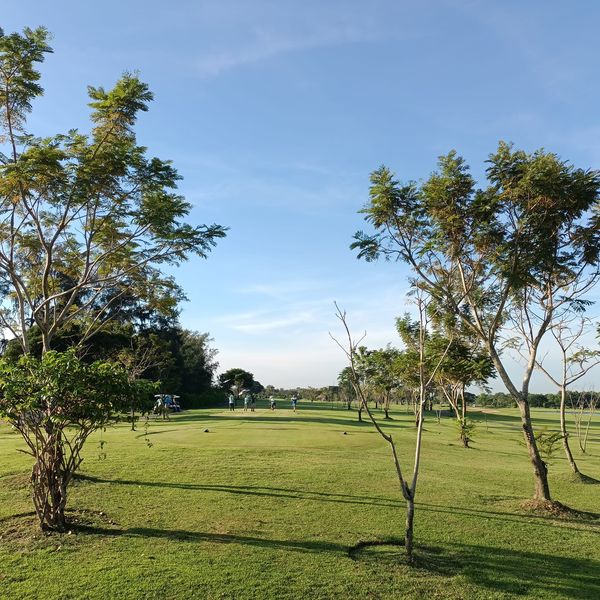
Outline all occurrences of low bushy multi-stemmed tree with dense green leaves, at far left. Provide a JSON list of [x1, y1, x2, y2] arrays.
[[0, 350, 153, 531]]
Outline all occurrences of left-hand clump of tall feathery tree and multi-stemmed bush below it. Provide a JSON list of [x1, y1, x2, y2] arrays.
[[0, 28, 225, 529]]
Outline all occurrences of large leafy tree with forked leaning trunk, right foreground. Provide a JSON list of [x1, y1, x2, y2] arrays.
[[352, 143, 600, 501]]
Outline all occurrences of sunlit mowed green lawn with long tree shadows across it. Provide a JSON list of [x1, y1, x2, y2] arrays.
[[0, 403, 600, 600]]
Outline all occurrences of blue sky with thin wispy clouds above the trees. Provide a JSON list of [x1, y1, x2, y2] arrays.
[[0, 0, 600, 390]]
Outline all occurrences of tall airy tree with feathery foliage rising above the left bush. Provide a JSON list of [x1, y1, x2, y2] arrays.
[[0, 28, 225, 353]]
